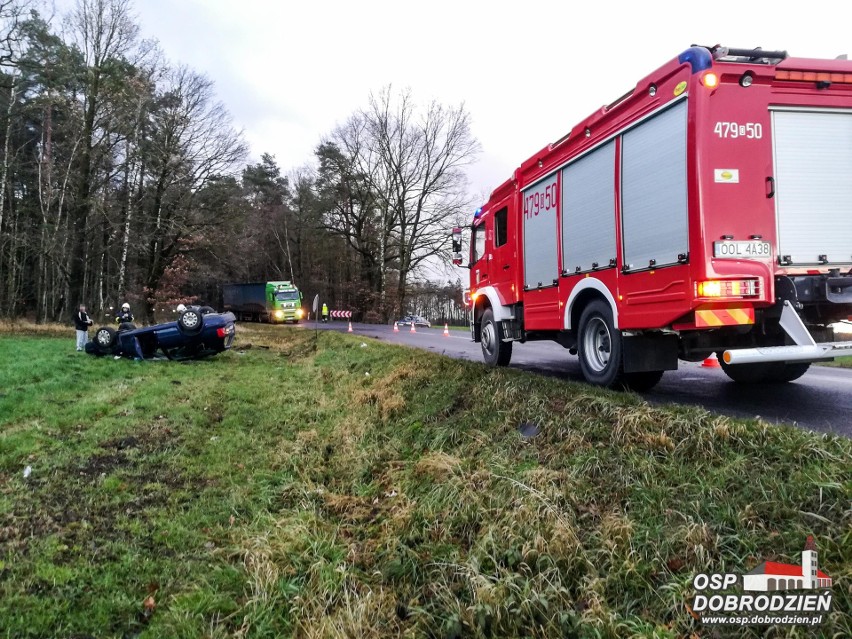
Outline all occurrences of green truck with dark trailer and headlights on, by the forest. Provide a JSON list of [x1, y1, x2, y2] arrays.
[[222, 282, 305, 324]]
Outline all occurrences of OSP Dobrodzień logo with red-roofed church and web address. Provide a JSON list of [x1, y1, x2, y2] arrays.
[[687, 535, 832, 626]]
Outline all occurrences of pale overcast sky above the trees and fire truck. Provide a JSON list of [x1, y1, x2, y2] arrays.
[[113, 0, 852, 200]]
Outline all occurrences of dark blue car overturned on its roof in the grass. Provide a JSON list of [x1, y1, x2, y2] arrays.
[[86, 306, 235, 360]]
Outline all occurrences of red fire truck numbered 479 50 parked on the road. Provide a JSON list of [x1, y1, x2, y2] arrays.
[[453, 46, 852, 390]]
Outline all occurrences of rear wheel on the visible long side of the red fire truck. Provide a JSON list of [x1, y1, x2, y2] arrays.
[[577, 300, 627, 388]]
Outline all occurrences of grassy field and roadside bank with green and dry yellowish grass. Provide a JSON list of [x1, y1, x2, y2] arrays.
[[0, 325, 852, 638]]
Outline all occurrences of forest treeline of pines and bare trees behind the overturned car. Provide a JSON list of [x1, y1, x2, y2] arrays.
[[0, 0, 472, 322]]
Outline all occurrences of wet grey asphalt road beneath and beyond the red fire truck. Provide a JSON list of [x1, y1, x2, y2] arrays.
[[300, 322, 852, 437]]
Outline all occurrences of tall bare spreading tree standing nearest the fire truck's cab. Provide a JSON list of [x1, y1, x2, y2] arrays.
[[332, 87, 479, 318]]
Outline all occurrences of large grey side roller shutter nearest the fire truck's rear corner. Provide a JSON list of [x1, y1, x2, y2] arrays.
[[621, 100, 689, 270]]
